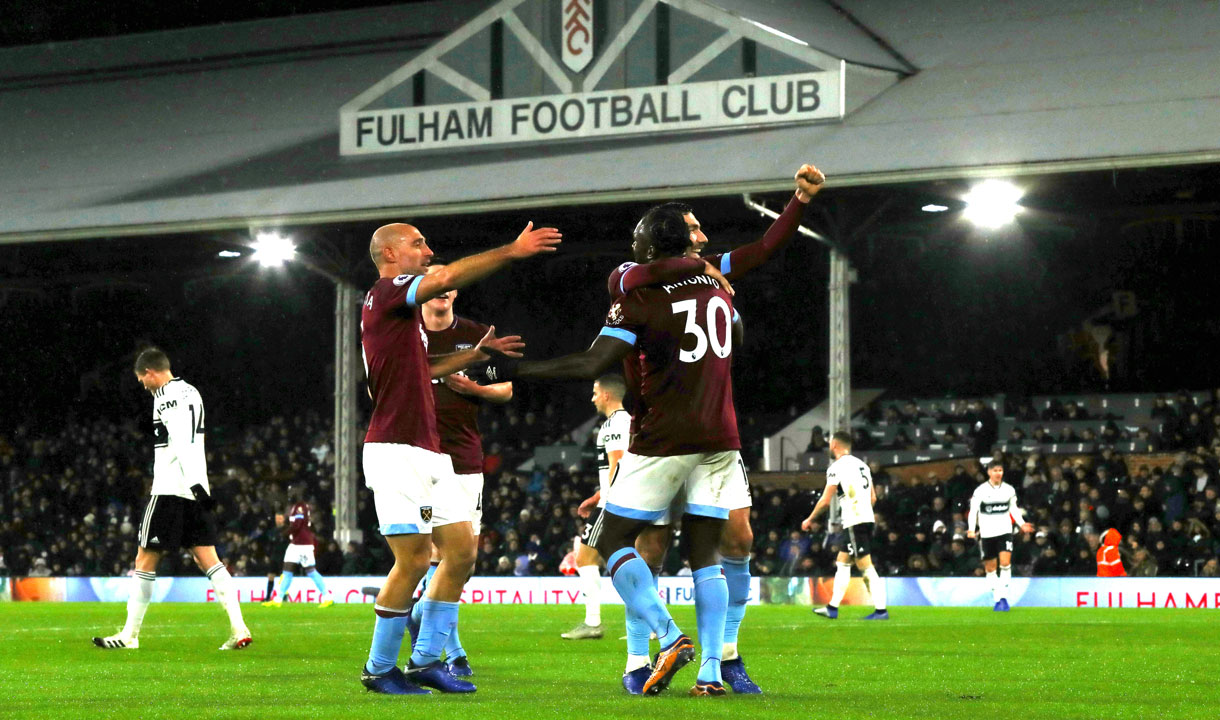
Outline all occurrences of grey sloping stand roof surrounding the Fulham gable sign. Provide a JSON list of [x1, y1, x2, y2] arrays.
[[0, 0, 1220, 243]]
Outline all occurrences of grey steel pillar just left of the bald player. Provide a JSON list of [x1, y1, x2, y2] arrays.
[[334, 282, 364, 545]]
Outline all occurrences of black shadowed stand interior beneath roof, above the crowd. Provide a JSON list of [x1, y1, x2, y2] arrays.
[[7, 161, 1220, 432]]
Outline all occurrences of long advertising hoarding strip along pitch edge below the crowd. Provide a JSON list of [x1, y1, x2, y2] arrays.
[[0, 577, 1220, 610]]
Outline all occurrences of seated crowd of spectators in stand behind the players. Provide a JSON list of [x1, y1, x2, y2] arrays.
[[0, 398, 1220, 576]]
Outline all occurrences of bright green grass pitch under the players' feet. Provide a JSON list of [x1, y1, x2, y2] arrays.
[[0, 603, 1220, 720]]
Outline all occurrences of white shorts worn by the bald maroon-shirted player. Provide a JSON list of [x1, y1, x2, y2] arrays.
[[364, 443, 458, 535]]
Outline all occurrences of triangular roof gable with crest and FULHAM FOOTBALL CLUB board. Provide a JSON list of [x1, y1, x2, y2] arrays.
[[339, 0, 847, 155]]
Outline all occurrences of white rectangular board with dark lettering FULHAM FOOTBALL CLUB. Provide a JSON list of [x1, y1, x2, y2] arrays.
[[339, 71, 843, 155]]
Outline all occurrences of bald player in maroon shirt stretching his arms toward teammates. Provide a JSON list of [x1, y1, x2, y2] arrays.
[[360, 222, 562, 694]]
